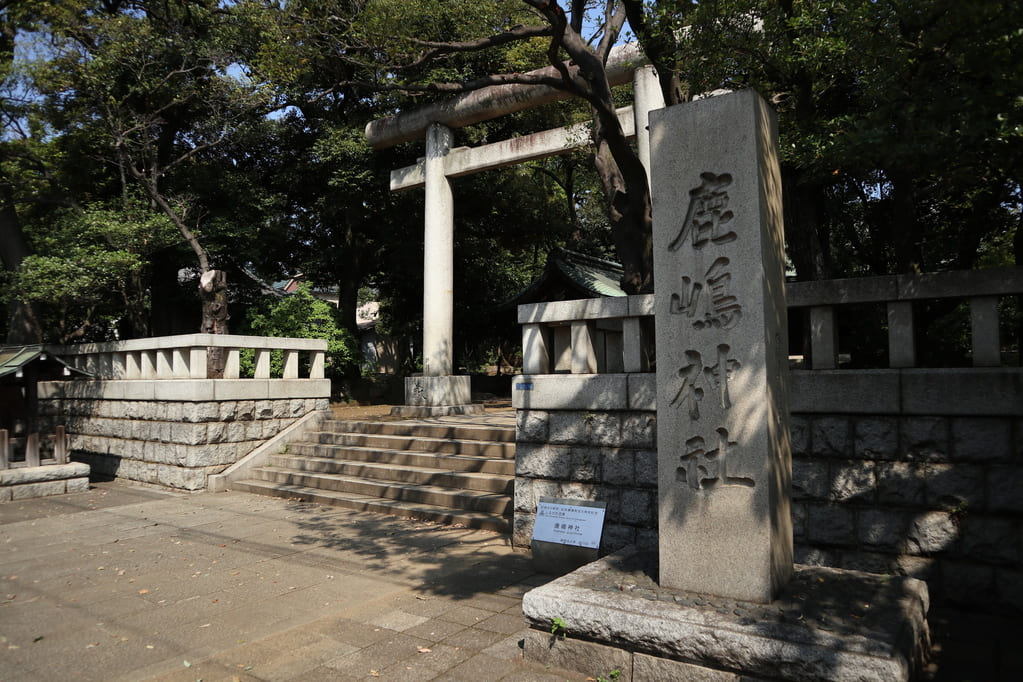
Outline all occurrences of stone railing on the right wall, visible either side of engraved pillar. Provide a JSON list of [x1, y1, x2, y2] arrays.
[[519, 268, 1023, 374]]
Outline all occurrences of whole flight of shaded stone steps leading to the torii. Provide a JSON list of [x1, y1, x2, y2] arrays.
[[231, 419, 515, 533]]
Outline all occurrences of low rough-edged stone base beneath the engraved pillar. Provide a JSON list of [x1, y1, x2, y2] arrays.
[[523, 549, 929, 682]]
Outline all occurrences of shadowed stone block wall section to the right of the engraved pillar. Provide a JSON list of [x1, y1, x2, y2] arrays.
[[792, 414, 1023, 611]]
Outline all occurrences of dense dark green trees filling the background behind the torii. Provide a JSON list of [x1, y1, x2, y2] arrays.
[[0, 0, 1023, 368]]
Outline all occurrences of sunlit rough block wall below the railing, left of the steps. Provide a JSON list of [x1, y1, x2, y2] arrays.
[[40, 388, 329, 491]]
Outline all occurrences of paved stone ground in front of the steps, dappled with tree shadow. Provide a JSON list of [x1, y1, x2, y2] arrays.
[[0, 482, 1023, 681]]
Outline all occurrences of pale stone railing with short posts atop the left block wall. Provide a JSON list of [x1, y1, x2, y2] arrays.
[[50, 334, 326, 380]]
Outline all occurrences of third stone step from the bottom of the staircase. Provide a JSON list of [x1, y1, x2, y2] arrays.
[[270, 453, 515, 495]]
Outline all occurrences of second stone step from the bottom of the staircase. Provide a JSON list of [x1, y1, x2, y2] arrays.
[[253, 466, 512, 516]]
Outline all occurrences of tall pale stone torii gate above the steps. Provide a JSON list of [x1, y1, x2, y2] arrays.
[[366, 43, 664, 416]]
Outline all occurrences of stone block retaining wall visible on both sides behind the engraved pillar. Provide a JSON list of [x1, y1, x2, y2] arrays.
[[514, 374, 1023, 611]]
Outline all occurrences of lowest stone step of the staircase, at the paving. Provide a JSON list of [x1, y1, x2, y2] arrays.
[[231, 480, 512, 533]]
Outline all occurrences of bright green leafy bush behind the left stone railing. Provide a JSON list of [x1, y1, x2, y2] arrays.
[[241, 283, 359, 378]]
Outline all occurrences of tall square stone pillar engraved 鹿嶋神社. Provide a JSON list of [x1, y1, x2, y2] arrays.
[[650, 90, 793, 602]]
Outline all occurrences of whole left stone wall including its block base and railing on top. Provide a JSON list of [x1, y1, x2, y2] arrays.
[[38, 334, 330, 490]]
